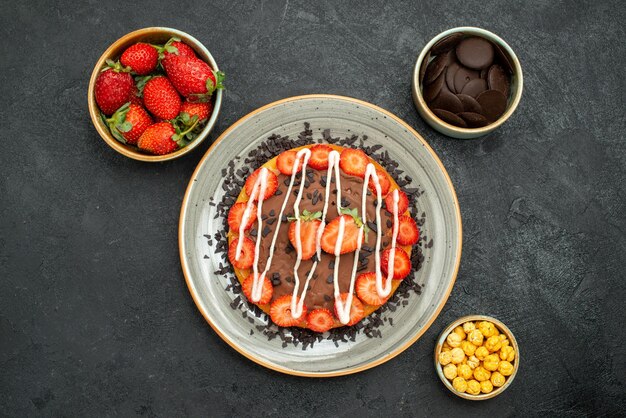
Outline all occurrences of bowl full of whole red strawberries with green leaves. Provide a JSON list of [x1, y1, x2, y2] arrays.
[[88, 28, 224, 162]]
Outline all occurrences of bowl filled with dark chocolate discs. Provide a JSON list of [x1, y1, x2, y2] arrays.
[[413, 27, 524, 139]]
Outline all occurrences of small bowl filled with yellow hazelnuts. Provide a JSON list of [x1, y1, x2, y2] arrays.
[[435, 315, 519, 401]]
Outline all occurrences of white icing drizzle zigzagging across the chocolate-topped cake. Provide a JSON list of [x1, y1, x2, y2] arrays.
[[235, 148, 399, 325]]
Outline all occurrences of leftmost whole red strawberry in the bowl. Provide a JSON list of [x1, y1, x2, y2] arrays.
[[94, 60, 135, 116]]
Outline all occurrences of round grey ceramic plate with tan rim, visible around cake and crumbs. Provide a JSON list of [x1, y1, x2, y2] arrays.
[[179, 95, 462, 377]]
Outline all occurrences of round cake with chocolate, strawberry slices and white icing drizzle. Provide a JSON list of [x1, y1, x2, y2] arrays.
[[227, 144, 419, 332]]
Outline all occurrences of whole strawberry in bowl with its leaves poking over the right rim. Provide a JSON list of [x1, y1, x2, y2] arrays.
[[164, 55, 224, 101]]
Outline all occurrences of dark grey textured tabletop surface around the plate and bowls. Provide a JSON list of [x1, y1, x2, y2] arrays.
[[0, 0, 626, 416]]
